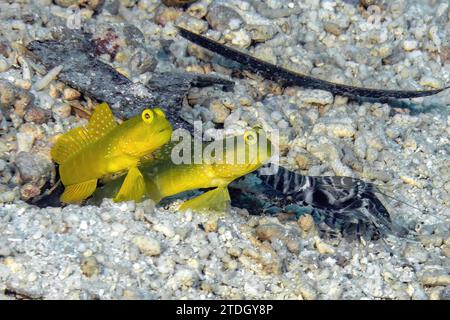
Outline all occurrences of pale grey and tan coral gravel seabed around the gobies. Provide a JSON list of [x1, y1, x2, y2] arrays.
[[0, 0, 450, 299]]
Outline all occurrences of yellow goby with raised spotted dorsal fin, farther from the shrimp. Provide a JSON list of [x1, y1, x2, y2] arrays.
[[51, 103, 172, 203]]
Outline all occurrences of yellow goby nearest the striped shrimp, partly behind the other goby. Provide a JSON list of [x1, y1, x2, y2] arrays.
[[94, 130, 273, 212]]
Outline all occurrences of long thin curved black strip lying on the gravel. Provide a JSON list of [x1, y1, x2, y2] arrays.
[[178, 27, 450, 99]]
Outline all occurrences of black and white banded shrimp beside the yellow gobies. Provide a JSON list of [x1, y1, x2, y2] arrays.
[[258, 167, 414, 240]]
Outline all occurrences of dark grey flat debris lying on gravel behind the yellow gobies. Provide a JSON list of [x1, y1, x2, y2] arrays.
[[27, 30, 233, 132]]
